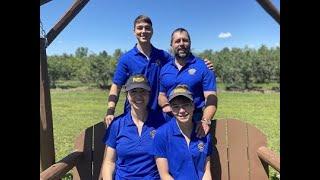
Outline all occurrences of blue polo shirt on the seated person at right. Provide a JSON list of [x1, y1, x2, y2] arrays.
[[152, 118, 212, 180]]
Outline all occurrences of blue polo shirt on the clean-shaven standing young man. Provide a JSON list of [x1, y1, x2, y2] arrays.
[[113, 45, 172, 112]]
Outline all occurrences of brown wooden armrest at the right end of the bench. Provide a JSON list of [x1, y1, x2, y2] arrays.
[[257, 146, 280, 173]]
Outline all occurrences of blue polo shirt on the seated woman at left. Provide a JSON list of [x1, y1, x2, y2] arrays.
[[104, 112, 164, 180]]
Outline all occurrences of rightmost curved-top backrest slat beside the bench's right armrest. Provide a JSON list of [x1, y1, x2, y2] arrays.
[[247, 124, 269, 180]]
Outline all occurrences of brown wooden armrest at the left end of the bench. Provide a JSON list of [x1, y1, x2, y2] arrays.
[[40, 151, 83, 180]]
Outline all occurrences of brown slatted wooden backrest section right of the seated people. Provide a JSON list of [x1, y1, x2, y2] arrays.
[[211, 119, 269, 180]]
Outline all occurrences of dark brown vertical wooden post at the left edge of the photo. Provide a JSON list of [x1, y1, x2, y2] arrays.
[[40, 38, 55, 172]]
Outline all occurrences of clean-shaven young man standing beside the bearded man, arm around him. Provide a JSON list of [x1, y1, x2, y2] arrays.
[[104, 15, 213, 125]]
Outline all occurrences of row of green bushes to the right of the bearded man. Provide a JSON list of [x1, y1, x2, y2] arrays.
[[199, 45, 280, 89]]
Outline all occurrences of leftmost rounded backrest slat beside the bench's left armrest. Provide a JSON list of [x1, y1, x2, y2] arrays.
[[72, 126, 93, 180]]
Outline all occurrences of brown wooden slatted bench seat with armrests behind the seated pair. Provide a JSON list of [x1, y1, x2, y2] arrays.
[[40, 119, 280, 180]]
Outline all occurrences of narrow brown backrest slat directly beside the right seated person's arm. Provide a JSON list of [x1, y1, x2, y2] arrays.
[[210, 120, 229, 180]]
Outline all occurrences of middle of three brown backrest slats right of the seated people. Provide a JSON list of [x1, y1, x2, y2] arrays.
[[227, 119, 249, 180]]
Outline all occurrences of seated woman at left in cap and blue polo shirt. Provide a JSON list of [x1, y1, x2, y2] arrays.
[[102, 74, 168, 180]]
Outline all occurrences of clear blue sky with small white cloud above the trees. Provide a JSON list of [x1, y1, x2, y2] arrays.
[[40, 0, 280, 55]]
